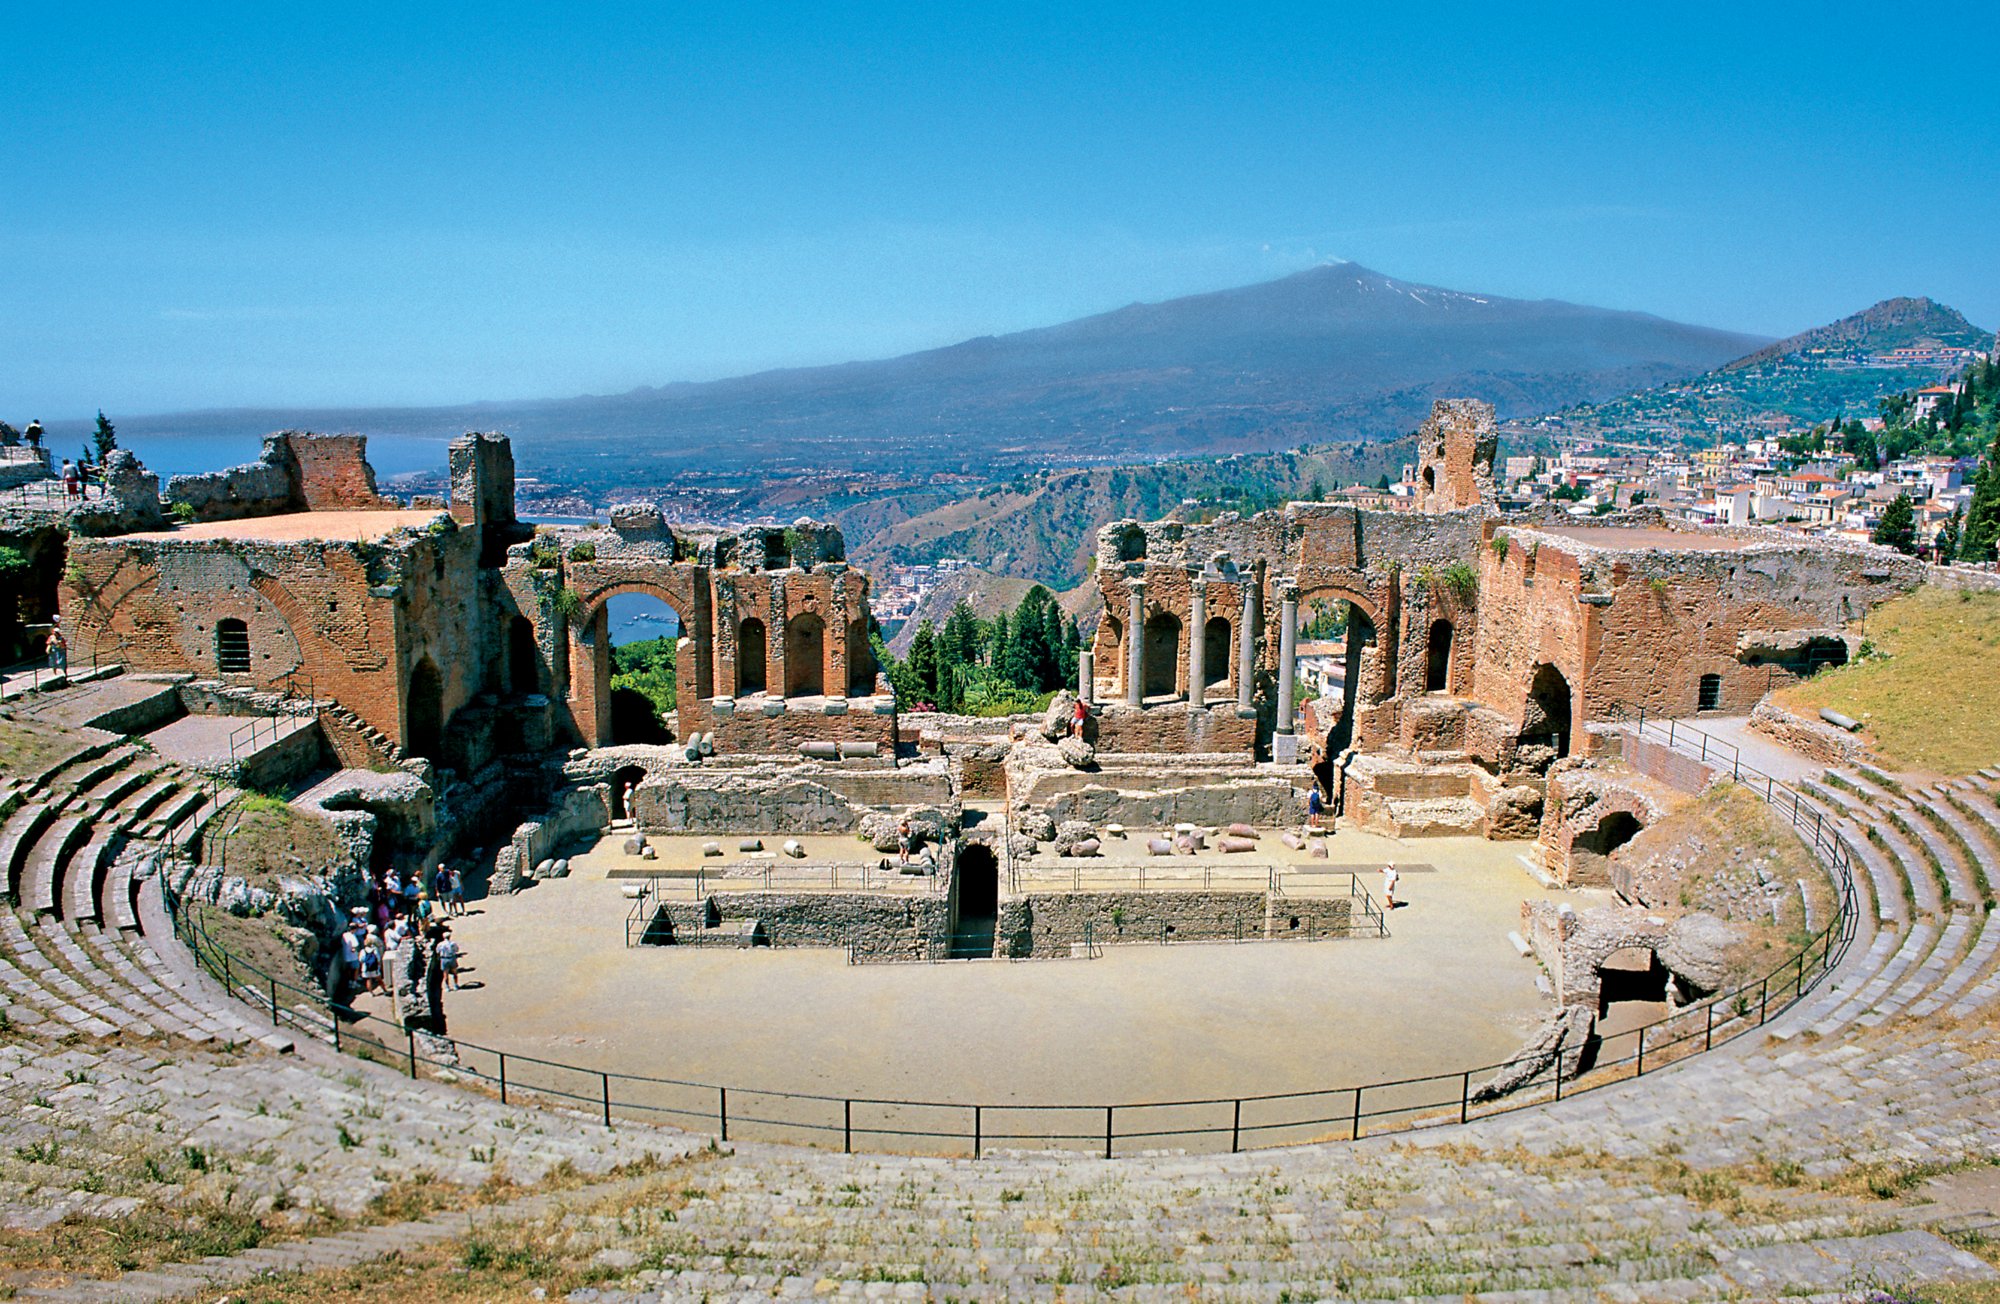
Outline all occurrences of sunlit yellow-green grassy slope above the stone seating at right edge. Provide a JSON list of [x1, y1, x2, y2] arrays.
[[1776, 588, 2000, 774]]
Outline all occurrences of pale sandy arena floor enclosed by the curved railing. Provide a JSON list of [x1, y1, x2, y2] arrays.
[[376, 832, 1588, 1102]]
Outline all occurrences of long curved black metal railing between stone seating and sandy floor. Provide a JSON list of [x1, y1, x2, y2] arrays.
[[158, 744, 1858, 1158]]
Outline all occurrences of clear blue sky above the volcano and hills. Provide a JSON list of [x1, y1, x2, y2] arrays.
[[0, 4, 2000, 424]]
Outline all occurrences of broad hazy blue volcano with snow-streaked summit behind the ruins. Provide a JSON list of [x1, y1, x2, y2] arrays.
[[82, 262, 1764, 490]]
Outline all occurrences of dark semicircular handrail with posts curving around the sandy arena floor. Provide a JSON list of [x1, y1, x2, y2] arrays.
[[160, 726, 1858, 1158]]
